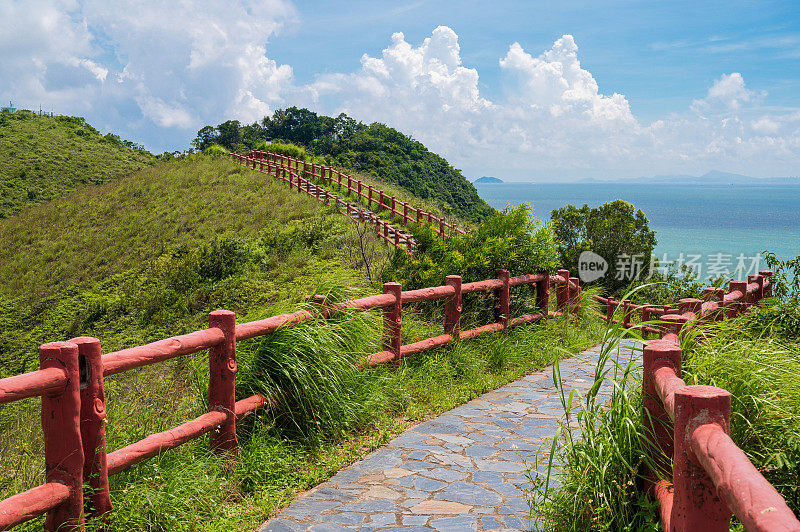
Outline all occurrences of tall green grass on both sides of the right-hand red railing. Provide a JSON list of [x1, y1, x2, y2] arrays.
[[529, 294, 800, 531]]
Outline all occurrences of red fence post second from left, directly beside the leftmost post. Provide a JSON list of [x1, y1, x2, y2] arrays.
[[70, 336, 114, 516]]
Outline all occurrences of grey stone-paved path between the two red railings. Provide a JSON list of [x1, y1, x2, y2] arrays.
[[259, 344, 631, 532]]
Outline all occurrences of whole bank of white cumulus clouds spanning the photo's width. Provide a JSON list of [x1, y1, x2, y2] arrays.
[[0, 10, 800, 179]]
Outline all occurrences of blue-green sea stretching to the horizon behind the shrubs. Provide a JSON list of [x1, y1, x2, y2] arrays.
[[475, 183, 800, 279]]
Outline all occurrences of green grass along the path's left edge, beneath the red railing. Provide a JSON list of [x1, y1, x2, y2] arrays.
[[0, 282, 601, 531]]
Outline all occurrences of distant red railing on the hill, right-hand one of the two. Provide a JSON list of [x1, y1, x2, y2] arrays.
[[249, 150, 467, 238]]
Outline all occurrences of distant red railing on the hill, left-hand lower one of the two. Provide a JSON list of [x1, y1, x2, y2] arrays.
[[231, 153, 417, 253]]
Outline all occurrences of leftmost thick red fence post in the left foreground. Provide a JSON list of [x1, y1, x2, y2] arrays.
[[39, 342, 83, 532]]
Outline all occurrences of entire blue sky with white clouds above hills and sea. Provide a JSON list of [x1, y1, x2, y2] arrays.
[[0, 0, 800, 182]]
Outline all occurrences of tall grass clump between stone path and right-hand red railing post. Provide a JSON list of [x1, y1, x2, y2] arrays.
[[527, 300, 663, 532]]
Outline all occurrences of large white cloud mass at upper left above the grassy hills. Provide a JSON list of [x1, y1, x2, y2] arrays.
[[0, 0, 295, 149]]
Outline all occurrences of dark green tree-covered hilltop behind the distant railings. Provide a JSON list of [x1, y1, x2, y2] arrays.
[[193, 107, 493, 222]]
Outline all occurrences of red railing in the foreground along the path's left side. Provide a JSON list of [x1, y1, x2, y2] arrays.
[[0, 270, 580, 531]]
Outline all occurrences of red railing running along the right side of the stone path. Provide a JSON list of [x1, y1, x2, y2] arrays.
[[595, 270, 800, 532]]
